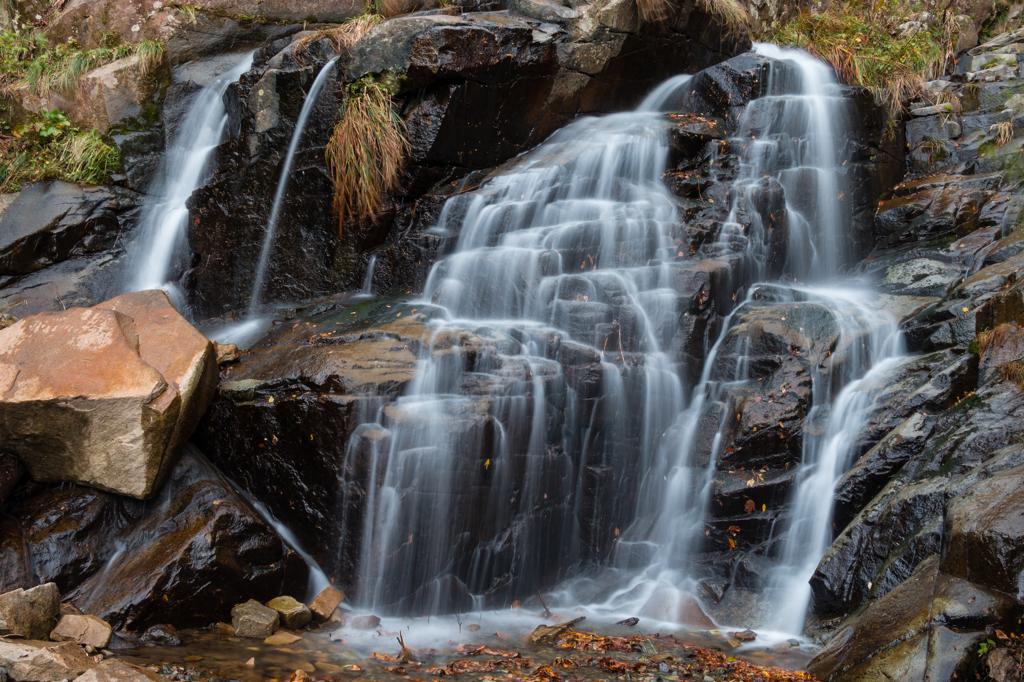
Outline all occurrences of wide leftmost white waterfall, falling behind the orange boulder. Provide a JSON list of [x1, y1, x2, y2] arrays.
[[127, 52, 254, 309]]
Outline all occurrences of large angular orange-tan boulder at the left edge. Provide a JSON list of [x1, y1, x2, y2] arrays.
[[0, 292, 217, 499]]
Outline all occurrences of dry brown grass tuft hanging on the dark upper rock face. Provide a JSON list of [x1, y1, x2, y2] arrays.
[[326, 79, 409, 233]]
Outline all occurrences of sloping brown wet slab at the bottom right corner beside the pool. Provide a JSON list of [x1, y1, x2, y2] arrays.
[[808, 557, 1014, 682]]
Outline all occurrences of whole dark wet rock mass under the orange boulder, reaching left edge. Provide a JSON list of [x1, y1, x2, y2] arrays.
[[0, 453, 308, 631]]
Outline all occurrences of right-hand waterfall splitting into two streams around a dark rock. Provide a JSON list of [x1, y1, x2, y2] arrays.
[[603, 45, 902, 635]]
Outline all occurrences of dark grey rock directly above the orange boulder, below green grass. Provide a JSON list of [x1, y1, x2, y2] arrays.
[[0, 181, 139, 317]]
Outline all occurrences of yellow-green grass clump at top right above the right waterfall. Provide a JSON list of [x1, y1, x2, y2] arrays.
[[762, 2, 959, 116]]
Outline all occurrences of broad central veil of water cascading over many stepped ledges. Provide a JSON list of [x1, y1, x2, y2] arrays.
[[344, 89, 686, 612]]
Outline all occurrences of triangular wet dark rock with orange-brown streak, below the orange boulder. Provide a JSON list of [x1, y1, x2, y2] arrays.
[[69, 451, 308, 637]]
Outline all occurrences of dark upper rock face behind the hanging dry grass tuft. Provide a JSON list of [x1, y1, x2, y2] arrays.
[[183, 0, 745, 316]]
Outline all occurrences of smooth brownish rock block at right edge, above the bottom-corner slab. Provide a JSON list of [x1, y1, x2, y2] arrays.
[[942, 467, 1024, 599]]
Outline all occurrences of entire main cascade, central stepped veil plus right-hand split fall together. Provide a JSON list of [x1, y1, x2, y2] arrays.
[[337, 45, 913, 634]]
